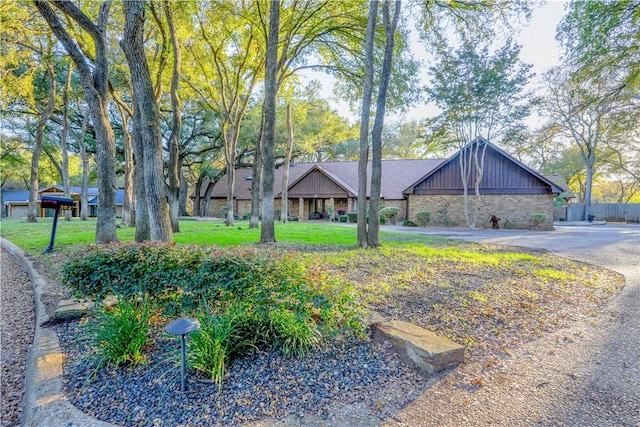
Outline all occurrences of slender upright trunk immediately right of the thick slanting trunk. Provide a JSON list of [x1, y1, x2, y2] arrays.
[[164, 0, 182, 233]]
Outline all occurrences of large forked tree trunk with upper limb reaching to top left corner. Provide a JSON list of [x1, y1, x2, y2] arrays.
[[33, 0, 117, 243]]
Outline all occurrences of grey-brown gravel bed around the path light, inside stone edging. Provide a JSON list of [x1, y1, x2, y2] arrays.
[[56, 321, 427, 426]]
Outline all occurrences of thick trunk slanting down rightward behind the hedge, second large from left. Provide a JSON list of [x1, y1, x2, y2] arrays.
[[121, 1, 173, 242]]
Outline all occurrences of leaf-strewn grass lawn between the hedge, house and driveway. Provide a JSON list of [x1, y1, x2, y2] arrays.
[[1, 220, 624, 362]]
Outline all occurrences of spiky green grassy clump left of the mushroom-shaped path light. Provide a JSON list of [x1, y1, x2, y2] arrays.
[[86, 298, 151, 367]]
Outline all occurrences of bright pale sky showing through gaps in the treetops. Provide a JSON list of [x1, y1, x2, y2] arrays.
[[303, 0, 568, 128]]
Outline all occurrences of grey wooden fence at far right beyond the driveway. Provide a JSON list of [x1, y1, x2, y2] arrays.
[[553, 203, 640, 222]]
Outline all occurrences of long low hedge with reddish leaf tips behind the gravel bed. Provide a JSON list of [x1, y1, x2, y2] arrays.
[[63, 243, 362, 336]]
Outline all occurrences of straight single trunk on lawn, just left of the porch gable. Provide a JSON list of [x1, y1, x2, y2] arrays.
[[260, 0, 280, 244]]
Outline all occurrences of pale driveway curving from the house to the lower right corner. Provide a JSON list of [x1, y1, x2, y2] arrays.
[[383, 224, 640, 427]]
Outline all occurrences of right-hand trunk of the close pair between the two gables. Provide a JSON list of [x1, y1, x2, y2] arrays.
[[367, 0, 401, 247]]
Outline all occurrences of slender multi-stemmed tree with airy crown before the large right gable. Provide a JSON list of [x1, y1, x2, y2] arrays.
[[427, 40, 532, 228]]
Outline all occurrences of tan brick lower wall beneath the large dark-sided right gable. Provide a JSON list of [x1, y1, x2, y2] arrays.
[[409, 194, 553, 230]]
